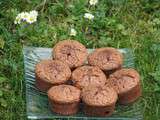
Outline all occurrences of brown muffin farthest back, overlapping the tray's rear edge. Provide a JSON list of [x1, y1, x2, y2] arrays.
[[53, 40, 87, 69]]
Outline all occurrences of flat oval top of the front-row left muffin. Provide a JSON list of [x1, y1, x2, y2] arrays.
[[48, 85, 80, 103]]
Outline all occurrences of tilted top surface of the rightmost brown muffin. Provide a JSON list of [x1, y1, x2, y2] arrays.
[[106, 69, 140, 94]]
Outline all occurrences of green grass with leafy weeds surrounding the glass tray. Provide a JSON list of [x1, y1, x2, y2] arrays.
[[0, 0, 160, 120]]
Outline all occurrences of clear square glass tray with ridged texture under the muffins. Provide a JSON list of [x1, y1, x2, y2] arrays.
[[23, 46, 143, 120]]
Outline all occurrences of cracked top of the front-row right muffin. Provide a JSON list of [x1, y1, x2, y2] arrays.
[[81, 86, 118, 106]]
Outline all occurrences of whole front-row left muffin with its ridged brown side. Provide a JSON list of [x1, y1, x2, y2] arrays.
[[48, 85, 80, 115]]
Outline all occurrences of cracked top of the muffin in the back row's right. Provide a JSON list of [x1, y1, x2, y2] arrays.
[[88, 47, 123, 71]]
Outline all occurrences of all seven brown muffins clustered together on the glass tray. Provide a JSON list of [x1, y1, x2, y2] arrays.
[[35, 40, 141, 116]]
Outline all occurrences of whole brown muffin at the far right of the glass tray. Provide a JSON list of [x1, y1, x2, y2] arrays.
[[108, 69, 141, 104]]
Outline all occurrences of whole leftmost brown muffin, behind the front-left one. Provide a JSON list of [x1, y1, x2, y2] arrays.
[[35, 60, 71, 92]]
